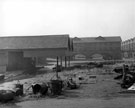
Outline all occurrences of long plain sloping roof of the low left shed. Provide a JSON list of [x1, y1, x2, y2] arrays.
[[0, 35, 69, 49]]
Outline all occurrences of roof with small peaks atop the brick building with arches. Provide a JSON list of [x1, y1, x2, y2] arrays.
[[74, 36, 121, 43]]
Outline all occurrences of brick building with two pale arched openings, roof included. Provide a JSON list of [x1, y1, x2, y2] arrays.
[[73, 36, 121, 60]]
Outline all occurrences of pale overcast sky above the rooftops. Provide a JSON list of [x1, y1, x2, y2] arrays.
[[0, 0, 135, 40]]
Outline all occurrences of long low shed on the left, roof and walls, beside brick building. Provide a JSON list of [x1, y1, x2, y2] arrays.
[[0, 35, 73, 72]]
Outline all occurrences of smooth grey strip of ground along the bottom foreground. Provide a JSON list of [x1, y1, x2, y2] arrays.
[[1, 98, 135, 108]]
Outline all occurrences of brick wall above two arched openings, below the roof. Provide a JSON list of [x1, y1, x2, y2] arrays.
[[74, 42, 121, 59]]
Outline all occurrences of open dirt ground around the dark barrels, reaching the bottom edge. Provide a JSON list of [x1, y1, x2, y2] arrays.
[[0, 65, 135, 108]]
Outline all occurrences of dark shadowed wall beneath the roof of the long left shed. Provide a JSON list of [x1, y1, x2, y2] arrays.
[[7, 48, 67, 71]]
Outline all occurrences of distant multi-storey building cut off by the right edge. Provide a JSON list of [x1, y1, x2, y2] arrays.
[[121, 37, 135, 59]]
